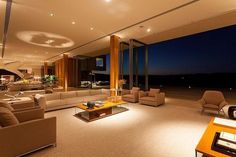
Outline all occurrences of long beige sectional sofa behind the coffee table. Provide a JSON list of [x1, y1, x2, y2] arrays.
[[38, 89, 110, 111]]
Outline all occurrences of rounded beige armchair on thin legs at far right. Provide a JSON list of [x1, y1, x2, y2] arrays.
[[199, 90, 228, 115]]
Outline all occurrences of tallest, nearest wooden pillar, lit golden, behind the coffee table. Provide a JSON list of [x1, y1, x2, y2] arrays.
[[110, 35, 120, 96]]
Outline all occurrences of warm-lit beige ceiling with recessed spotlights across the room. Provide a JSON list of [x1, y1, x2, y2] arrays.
[[0, 0, 236, 67]]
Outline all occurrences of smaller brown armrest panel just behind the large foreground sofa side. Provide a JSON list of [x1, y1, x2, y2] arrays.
[[13, 108, 44, 122]]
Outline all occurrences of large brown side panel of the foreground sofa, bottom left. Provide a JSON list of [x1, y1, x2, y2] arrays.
[[0, 117, 56, 156]]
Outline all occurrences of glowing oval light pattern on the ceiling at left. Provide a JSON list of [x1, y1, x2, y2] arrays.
[[16, 31, 74, 48]]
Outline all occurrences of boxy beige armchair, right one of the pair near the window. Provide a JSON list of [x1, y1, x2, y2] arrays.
[[139, 88, 165, 106]]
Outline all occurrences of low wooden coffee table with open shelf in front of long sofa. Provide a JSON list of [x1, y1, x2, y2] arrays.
[[75, 100, 128, 122]]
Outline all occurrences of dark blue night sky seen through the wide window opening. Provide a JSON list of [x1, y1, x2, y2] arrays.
[[104, 25, 236, 75]]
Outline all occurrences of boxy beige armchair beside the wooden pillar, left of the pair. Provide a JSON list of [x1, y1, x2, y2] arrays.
[[122, 87, 140, 103]]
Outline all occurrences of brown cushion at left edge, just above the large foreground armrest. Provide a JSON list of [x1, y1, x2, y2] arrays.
[[0, 107, 19, 127]]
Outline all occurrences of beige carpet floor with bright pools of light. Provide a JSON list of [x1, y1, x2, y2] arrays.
[[28, 98, 211, 157]]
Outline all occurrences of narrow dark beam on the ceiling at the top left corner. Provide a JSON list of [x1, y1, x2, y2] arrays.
[[2, 0, 12, 58]]
